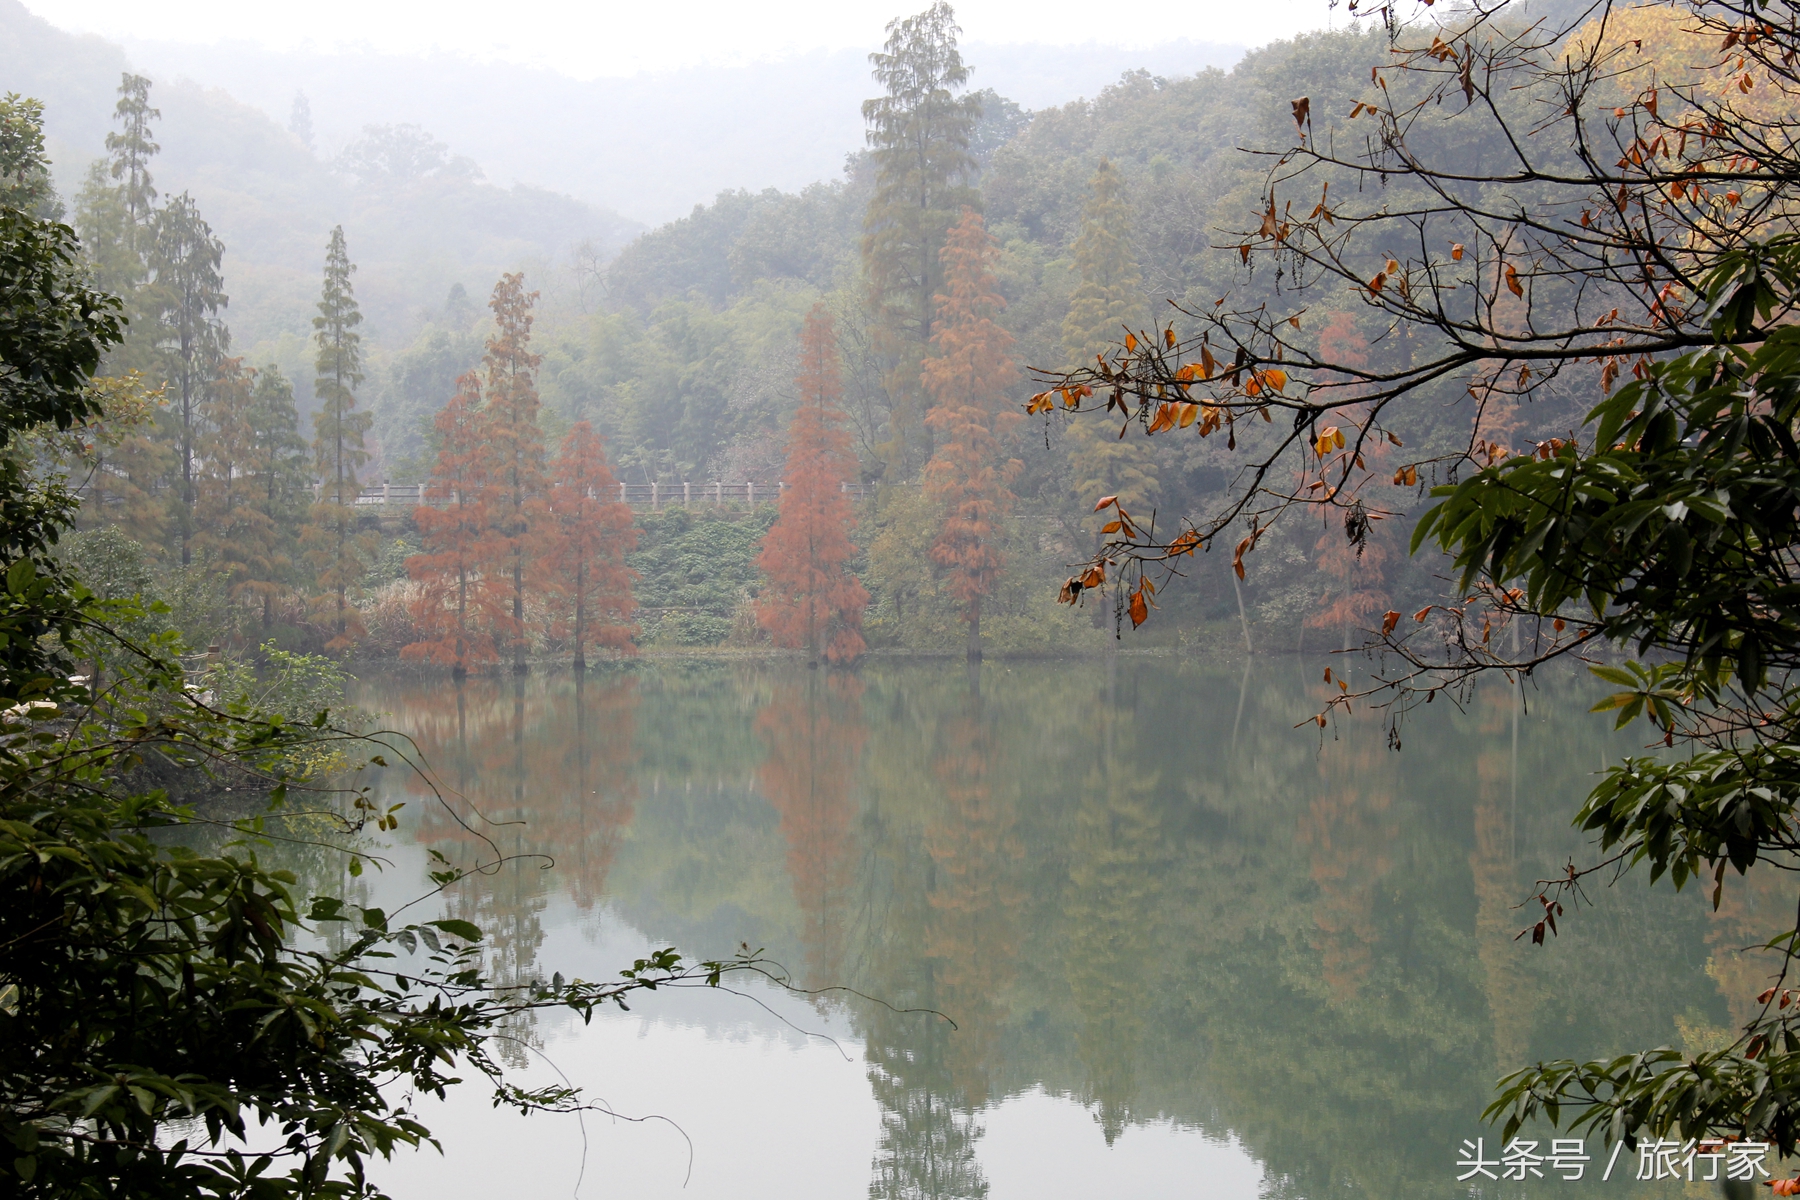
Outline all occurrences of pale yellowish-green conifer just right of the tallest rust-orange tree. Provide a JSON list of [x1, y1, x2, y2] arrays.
[[1062, 158, 1157, 528]]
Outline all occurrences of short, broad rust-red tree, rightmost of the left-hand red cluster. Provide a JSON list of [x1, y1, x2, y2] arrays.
[[544, 421, 637, 667]]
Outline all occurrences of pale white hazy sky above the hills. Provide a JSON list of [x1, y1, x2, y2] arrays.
[[25, 0, 1343, 79]]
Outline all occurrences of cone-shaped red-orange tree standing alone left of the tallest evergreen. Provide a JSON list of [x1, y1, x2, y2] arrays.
[[756, 304, 869, 662]]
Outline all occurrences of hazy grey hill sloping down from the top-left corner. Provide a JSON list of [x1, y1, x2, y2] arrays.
[[0, 0, 643, 354]]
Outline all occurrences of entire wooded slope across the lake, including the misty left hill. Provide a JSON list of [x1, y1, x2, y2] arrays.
[[10, 4, 1573, 667]]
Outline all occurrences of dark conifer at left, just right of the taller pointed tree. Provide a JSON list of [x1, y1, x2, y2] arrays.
[[148, 193, 228, 567]]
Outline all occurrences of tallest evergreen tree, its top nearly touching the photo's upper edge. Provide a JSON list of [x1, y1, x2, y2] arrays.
[[862, 0, 981, 482]]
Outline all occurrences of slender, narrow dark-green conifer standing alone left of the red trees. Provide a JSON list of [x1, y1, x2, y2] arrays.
[[302, 225, 369, 649]]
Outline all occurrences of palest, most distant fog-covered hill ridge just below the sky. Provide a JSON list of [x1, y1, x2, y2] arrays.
[[124, 41, 1244, 225]]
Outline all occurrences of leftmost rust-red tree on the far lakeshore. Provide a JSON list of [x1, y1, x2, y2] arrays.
[[400, 371, 502, 676]]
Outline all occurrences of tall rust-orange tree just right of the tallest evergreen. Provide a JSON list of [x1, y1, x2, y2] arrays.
[[922, 209, 1021, 658]]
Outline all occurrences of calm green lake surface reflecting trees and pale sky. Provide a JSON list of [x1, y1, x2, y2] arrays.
[[334, 657, 1742, 1200]]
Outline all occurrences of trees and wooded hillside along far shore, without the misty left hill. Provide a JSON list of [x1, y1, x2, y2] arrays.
[[28, 4, 1605, 667]]
